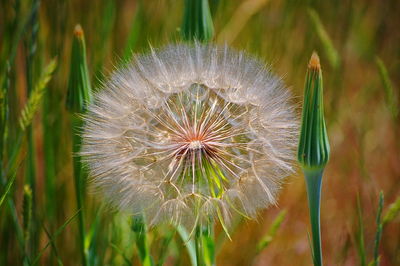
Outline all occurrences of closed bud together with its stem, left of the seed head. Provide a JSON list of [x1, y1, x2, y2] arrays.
[[67, 25, 91, 266]]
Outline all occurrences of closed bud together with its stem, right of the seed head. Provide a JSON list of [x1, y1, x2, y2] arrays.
[[298, 52, 330, 265]]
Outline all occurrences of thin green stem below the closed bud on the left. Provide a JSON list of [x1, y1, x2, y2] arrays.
[[72, 117, 87, 266]]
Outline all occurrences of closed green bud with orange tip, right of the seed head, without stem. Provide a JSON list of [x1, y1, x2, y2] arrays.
[[298, 52, 330, 170]]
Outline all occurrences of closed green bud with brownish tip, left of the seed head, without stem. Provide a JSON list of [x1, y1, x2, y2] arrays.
[[67, 25, 92, 113]]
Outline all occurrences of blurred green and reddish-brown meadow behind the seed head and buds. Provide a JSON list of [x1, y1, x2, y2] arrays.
[[0, 0, 400, 265]]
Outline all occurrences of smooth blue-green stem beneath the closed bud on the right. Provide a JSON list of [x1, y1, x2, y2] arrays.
[[304, 169, 323, 266]]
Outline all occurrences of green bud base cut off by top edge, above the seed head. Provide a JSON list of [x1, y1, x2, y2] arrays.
[[182, 0, 214, 41]]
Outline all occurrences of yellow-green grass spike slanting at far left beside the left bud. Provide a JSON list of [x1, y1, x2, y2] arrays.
[[19, 59, 57, 131]]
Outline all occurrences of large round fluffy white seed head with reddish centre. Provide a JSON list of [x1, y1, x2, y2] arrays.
[[81, 43, 298, 232]]
